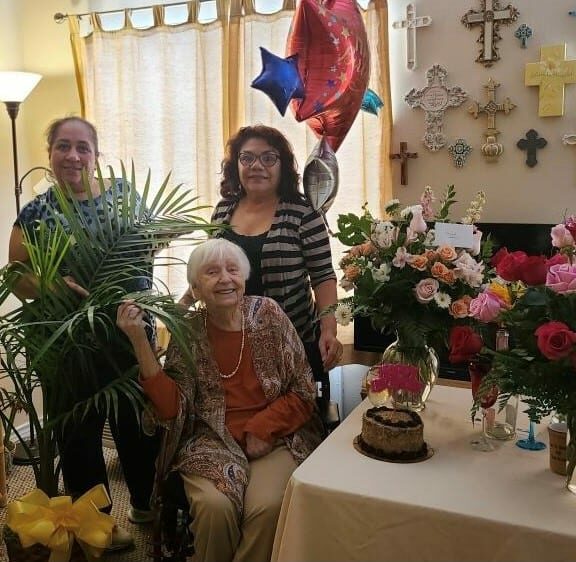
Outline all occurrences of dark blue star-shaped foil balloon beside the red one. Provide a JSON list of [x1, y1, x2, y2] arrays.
[[250, 47, 304, 115]]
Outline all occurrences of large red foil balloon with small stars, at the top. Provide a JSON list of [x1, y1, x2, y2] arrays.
[[286, 0, 370, 151]]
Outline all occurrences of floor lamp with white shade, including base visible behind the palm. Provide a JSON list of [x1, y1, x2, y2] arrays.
[[0, 72, 42, 464]]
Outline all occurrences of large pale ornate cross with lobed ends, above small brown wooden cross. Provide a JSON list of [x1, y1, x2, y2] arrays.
[[404, 64, 468, 152]]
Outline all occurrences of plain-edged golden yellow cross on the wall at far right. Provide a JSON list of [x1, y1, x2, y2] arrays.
[[524, 43, 576, 117]]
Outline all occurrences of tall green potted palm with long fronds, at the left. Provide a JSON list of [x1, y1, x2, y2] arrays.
[[0, 166, 219, 496]]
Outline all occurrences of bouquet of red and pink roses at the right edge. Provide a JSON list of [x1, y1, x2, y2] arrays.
[[470, 217, 576, 478]]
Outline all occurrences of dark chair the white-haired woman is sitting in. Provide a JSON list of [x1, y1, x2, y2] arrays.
[[150, 382, 340, 562]]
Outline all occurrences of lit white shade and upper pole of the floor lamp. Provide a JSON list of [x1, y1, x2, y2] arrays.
[[0, 72, 42, 214]]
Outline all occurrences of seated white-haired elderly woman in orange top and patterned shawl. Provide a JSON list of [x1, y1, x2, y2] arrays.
[[117, 239, 322, 562]]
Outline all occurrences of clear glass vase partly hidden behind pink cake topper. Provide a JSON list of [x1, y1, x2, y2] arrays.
[[382, 339, 438, 412]]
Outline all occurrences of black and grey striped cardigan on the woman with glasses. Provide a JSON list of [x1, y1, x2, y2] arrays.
[[212, 199, 336, 342]]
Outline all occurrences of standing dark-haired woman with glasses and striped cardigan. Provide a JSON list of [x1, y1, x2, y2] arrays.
[[181, 125, 342, 393]]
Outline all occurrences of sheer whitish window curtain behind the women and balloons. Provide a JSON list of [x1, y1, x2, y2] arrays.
[[71, 0, 389, 294]]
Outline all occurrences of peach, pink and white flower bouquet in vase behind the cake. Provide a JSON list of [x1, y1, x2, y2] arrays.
[[335, 186, 490, 409]]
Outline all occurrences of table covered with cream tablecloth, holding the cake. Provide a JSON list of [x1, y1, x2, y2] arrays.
[[272, 386, 576, 562]]
